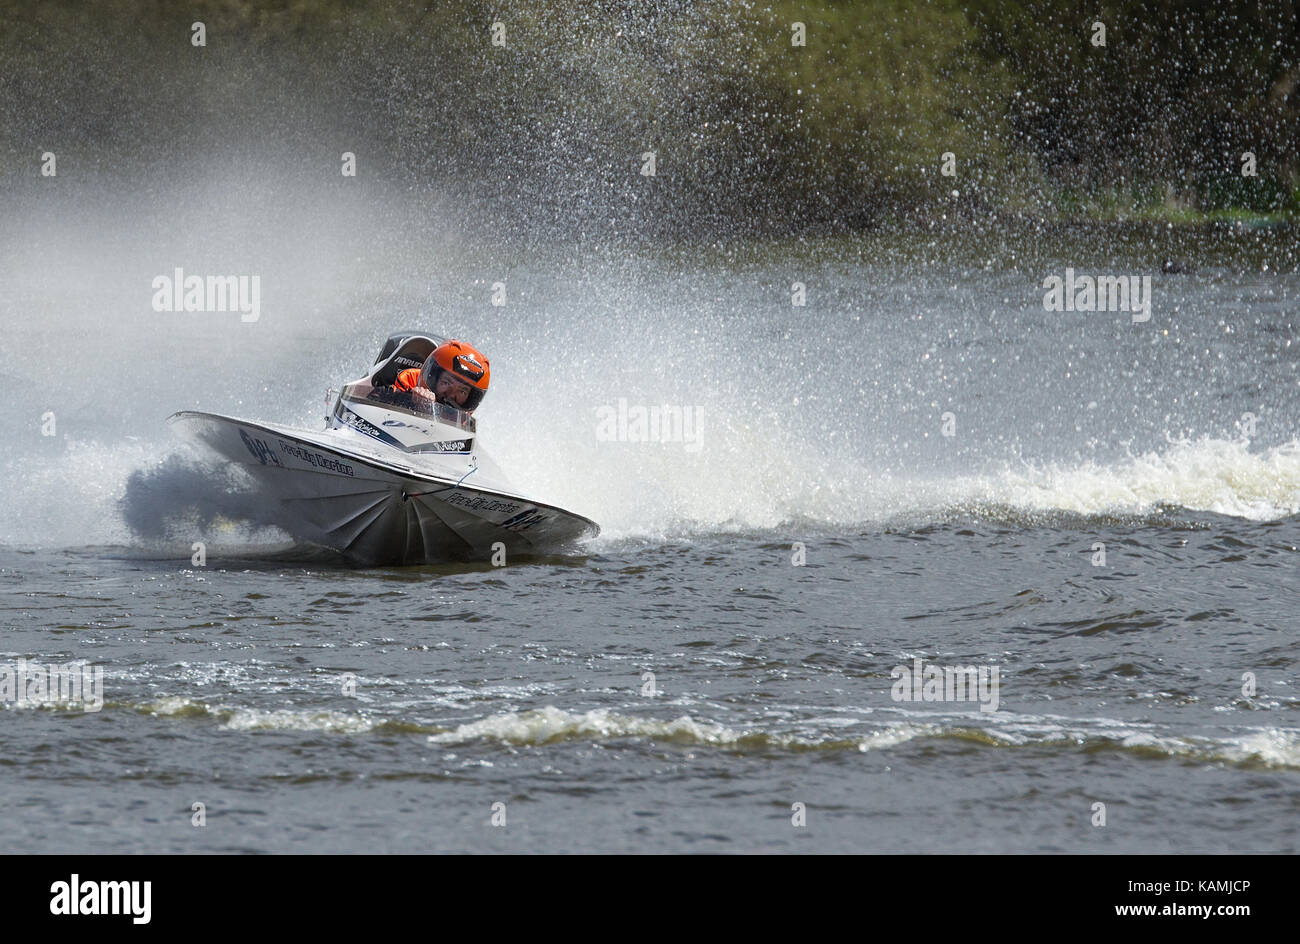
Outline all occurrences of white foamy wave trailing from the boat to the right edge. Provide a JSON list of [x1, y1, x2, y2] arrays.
[[588, 437, 1300, 540]]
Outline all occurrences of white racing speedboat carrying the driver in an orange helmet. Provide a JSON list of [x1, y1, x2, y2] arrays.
[[168, 333, 601, 564]]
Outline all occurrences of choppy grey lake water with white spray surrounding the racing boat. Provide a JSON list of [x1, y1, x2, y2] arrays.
[[0, 233, 1300, 853]]
